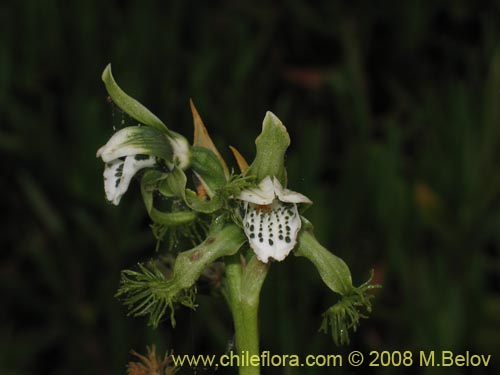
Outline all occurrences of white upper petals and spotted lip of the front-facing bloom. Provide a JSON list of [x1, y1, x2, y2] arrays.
[[238, 176, 312, 263]]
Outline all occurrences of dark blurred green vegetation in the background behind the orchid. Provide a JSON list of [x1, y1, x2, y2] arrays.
[[0, 0, 500, 374]]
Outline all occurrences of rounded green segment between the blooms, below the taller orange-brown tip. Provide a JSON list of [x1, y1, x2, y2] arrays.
[[191, 146, 227, 198]]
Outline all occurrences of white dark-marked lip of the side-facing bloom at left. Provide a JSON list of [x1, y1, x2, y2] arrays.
[[104, 155, 156, 206]]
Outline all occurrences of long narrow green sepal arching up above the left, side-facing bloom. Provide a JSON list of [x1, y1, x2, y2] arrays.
[[102, 64, 170, 132]]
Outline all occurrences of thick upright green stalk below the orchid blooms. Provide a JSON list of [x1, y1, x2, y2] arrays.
[[224, 254, 269, 375]]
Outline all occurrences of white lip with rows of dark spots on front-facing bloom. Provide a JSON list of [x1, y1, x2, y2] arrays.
[[243, 200, 302, 263]]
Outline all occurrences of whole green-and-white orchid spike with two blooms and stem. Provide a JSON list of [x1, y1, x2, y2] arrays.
[[97, 66, 376, 375]]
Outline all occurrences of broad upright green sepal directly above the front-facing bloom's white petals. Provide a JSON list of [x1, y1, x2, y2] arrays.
[[245, 112, 290, 187]]
